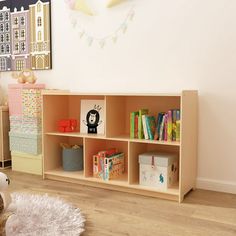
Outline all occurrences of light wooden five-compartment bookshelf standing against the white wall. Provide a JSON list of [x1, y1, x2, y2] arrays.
[[42, 90, 198, 202]]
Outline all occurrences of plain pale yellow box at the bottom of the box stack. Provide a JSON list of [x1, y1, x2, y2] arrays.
[[11, 151, 43, 175]]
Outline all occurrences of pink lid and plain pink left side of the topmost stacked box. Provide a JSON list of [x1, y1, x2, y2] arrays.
[[8, 84, 45, 116]]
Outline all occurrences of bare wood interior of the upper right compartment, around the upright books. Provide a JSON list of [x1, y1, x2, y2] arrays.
[[106, 95, 181, 138]]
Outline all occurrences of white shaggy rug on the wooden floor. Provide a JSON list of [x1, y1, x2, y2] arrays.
[[6, 193, 85, 236]]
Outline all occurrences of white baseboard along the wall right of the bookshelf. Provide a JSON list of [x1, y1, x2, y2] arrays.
[[197, 178, 236, 194]]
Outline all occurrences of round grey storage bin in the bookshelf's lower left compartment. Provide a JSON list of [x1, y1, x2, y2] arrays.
[[62, 147, 83, 171]]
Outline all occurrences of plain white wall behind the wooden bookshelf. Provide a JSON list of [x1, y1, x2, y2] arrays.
[[0, 0, 236, 193]]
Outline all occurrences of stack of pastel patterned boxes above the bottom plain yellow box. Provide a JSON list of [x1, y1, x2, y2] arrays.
[[8, 84, 45, 172]]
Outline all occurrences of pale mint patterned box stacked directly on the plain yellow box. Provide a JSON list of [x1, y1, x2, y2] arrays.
[[9, 131, 42, 155]]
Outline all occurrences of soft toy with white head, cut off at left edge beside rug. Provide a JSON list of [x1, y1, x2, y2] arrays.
[[0, 172, 12, 235]]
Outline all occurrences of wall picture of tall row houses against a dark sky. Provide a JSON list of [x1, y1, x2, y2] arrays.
[[0, 0, 52, 72]]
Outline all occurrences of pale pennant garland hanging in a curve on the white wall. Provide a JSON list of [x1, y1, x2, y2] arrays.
[[65, 0, 135, 49]]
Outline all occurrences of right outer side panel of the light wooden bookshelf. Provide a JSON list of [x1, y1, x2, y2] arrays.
[[180, 91, 198, 200]]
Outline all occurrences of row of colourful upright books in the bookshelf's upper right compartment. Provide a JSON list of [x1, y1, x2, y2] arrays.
[[130, 109, 180, 142]]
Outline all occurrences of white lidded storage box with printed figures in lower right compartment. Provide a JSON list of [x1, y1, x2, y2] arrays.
[[139, 152, 179, 189]]
